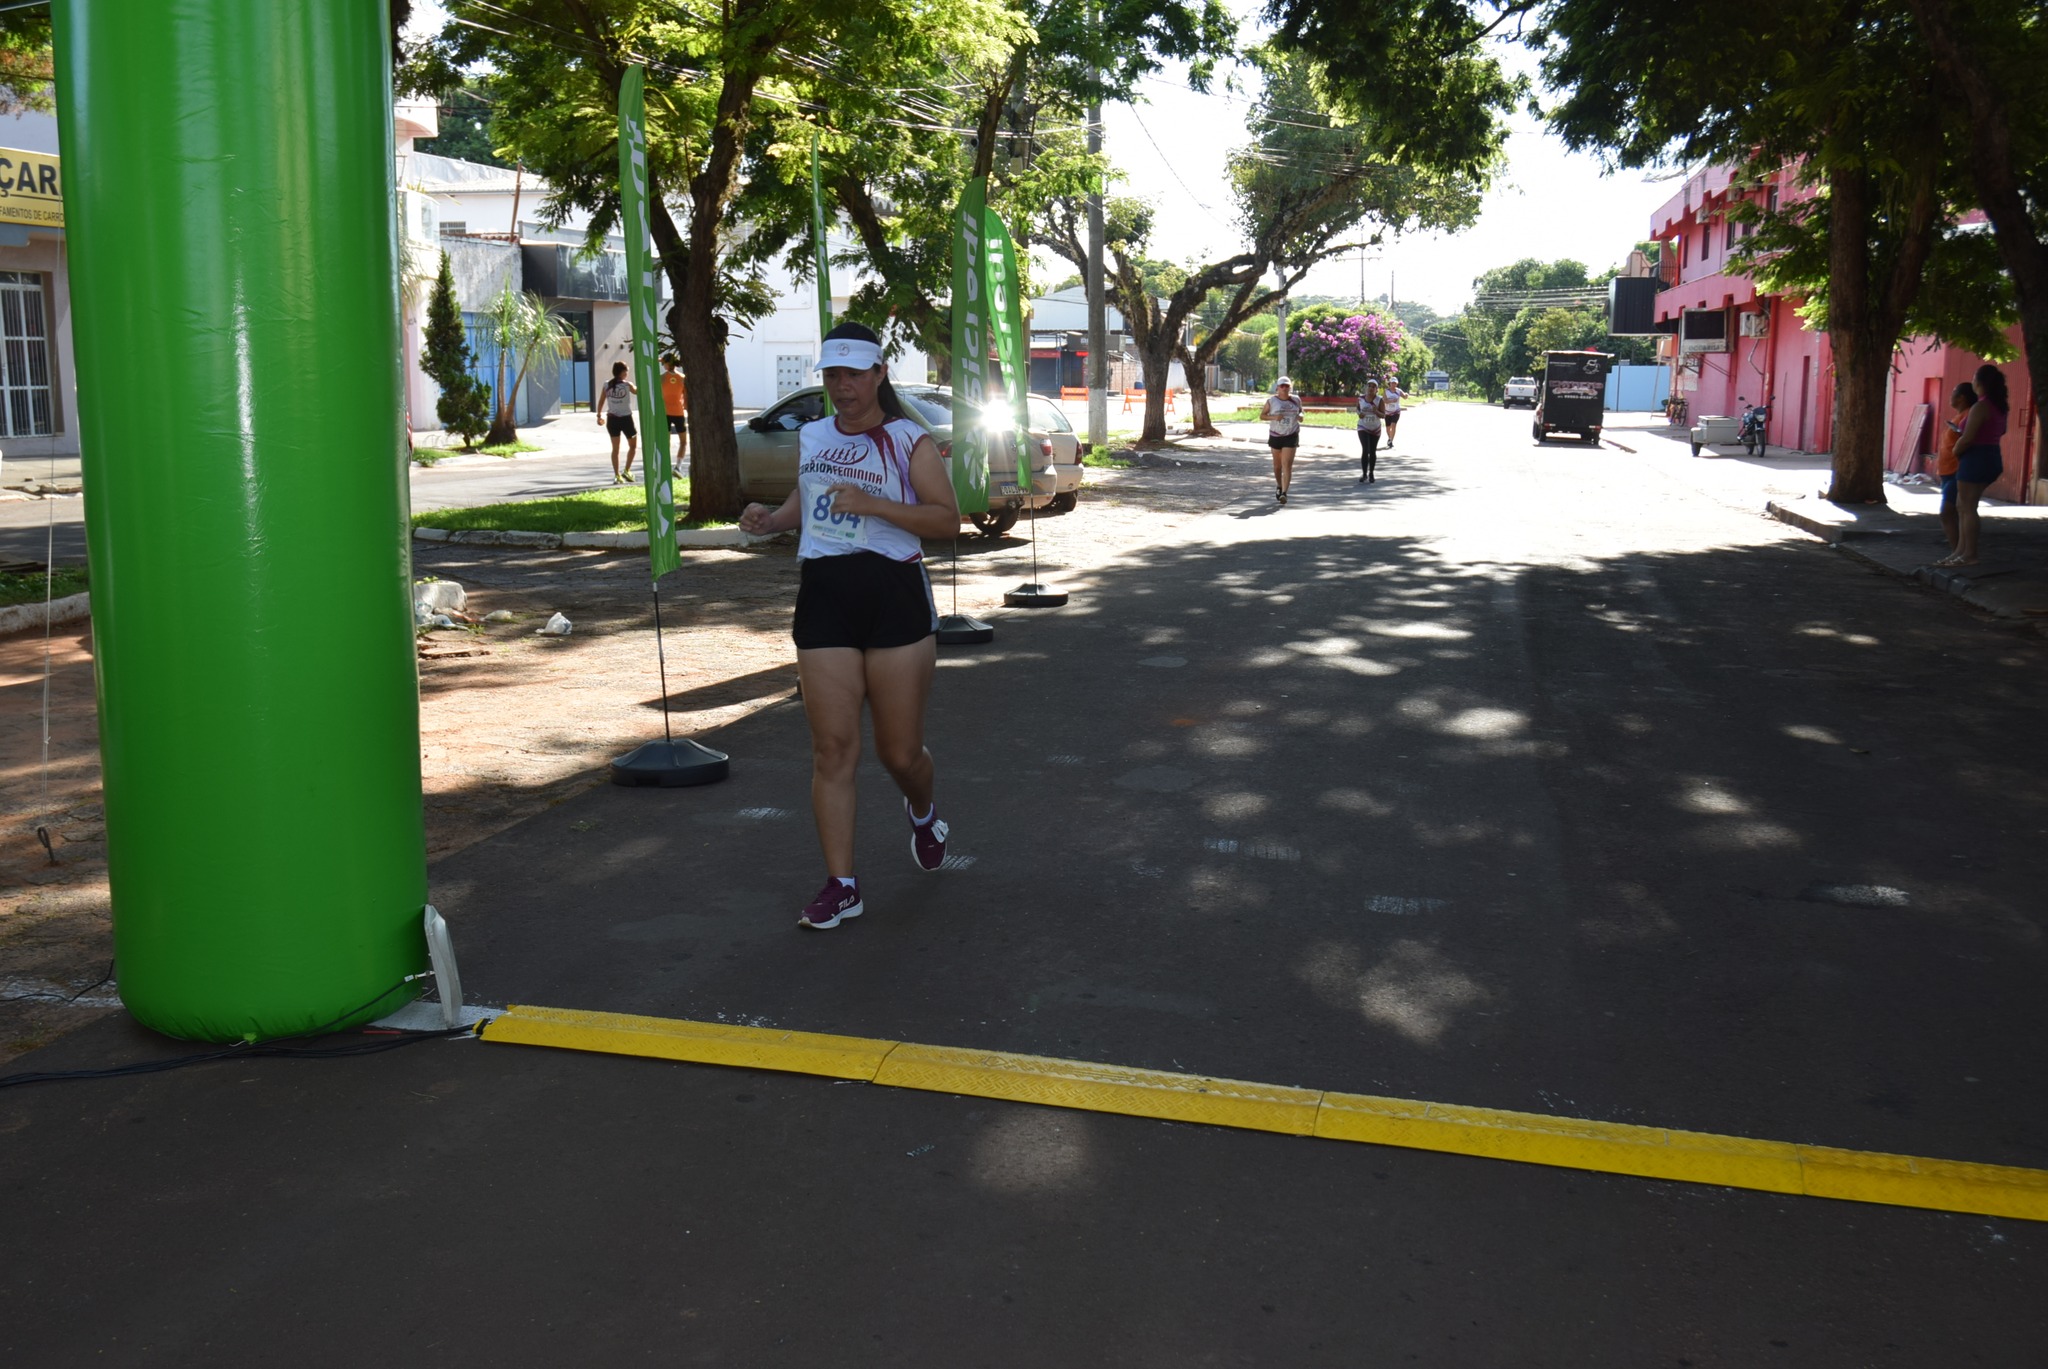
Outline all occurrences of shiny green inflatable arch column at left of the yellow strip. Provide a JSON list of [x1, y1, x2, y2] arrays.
[[53, 0, 426, 1041]]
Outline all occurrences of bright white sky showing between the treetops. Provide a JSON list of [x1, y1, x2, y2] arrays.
[[414, 0, 1677, 314]]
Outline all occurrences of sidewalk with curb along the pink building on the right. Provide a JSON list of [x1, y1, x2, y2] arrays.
[[1608, 405, 2048, 627]]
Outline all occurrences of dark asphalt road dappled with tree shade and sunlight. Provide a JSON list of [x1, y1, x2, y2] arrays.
[[0, 404, 2048, 1367]]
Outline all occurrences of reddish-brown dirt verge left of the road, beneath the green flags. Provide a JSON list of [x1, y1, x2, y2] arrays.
[[0, 457, 1266, 1060]]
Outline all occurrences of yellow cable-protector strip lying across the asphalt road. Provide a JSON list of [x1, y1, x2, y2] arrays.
[[479, 1004, 2048, 1221]]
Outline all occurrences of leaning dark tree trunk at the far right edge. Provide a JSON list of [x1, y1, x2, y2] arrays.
[[1907, 0, 2048, 500]]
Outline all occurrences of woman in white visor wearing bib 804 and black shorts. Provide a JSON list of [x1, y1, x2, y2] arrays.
[[739, 324, 961, 930]]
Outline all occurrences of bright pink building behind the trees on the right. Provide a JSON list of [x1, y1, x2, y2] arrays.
[[1651, 166, 2048, 504]]
